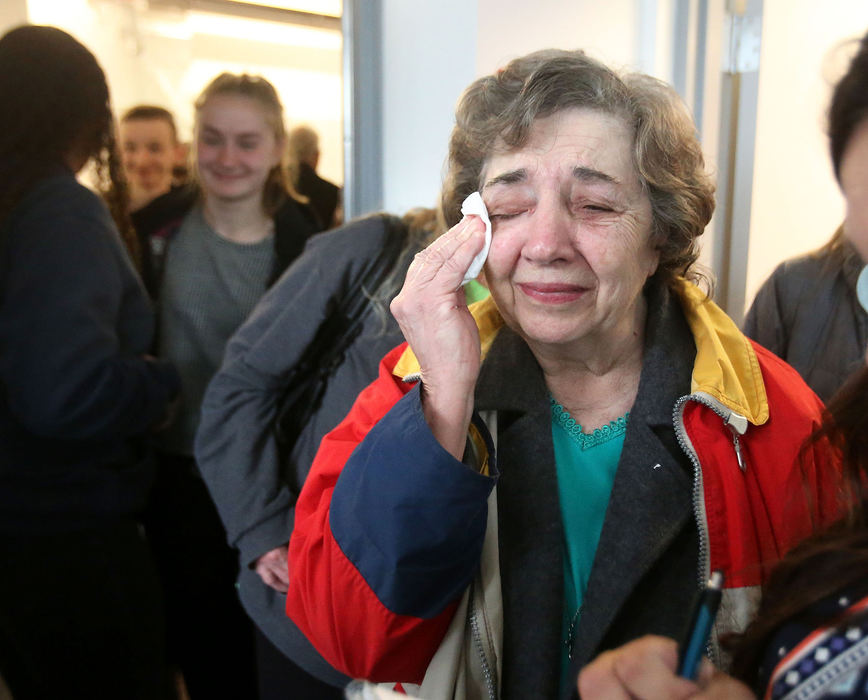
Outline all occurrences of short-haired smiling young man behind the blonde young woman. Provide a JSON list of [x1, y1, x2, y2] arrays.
[[118, 105, 197, 297]]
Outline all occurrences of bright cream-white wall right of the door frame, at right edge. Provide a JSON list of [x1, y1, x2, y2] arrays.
[[744, 0, 868, 312]]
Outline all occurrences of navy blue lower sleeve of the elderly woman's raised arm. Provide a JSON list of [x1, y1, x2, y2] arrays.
[[329, 386, 496, 618]]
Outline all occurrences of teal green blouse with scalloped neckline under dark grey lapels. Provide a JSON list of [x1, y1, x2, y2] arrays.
[[551, 399, 630, 685]]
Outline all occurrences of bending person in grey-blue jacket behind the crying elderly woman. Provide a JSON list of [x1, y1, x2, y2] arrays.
[[196, 209, 462, 700]]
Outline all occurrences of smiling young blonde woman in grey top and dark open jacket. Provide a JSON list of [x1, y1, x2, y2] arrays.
[[147, 73, 319, 700]]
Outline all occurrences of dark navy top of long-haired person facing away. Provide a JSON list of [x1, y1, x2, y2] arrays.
[[0, 171, 179, 532]]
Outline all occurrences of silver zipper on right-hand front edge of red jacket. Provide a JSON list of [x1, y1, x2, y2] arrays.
[[672, 392, 748, 662]]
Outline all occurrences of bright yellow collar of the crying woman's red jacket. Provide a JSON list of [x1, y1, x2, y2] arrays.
[[392, 279, 769, 425]]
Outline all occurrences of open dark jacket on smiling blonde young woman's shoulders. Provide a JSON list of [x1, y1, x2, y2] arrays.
[[131, 185, 323, 299]]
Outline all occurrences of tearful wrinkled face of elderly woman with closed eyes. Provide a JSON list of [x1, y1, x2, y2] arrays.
[[482, 109, 658, 356]]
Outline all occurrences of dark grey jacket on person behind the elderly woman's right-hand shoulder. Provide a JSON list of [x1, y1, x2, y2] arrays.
[[744, 241, 868, 401]]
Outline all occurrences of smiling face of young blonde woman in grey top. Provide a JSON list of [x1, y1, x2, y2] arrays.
[[196, 95, 283, 201]]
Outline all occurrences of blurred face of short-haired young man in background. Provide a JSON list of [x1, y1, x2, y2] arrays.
[[119, 119, 179, 204]]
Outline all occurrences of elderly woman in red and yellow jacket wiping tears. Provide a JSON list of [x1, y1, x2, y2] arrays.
[[287, 51, 836, 698]]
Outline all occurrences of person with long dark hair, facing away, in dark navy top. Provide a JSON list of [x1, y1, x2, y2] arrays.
[[0, 26, 178, 700]]
